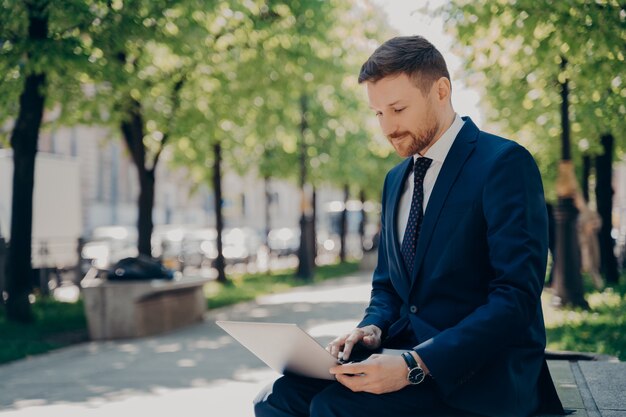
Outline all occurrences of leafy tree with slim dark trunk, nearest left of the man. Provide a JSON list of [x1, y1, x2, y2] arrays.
[[243, 1, 384, 272]]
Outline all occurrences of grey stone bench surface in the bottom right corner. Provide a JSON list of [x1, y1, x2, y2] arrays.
[[542, 359, 626, 417]]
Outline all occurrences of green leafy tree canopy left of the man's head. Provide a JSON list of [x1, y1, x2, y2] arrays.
[[0, 0, 397, 197]]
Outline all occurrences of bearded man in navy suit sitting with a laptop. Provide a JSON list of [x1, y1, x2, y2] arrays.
[[255, 36, 562, 417]]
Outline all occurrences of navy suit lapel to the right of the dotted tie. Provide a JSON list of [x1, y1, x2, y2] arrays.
[[411, 117, 479, 285]]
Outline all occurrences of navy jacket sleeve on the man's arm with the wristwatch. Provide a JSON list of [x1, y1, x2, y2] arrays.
[[415, 145, 548, 395]]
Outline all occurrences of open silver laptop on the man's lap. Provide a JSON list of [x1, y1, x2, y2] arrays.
[[215, 320, 339, 380]]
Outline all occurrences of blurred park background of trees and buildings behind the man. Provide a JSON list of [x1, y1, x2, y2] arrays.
[[0, 0, 626, 360]]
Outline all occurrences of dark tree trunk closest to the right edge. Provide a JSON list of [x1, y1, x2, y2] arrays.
[[596, 134, 619, 284]]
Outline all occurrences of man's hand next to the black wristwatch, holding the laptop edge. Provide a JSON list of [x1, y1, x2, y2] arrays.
[[330, 354, 409, 394]]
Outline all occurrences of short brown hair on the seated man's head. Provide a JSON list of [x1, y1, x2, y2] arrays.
[[359, 36, 450, 93]]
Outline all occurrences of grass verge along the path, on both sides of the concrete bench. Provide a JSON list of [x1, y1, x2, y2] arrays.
[[0, 262, 358, 364]]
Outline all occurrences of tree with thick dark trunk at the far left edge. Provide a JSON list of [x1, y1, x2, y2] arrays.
[[0, 0, 99, 322]]
